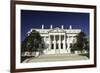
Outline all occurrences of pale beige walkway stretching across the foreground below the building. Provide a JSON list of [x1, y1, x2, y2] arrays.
[[23, 54, 88, 63]]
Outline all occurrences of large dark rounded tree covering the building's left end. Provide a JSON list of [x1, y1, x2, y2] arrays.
[[21, 30, 44, 55]]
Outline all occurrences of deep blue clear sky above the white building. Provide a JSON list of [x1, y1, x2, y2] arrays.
[[21, 10, 89, 41]]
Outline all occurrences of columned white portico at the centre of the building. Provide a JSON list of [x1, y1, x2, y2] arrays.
[[48, 28, 67, 53]]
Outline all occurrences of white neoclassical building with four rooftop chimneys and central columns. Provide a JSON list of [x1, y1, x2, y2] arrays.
[[28, 25, 81, 54]]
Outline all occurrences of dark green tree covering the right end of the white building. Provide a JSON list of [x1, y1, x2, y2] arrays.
[[71, 32, 89, 51]]
